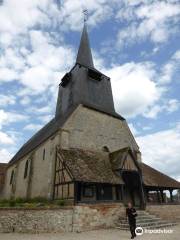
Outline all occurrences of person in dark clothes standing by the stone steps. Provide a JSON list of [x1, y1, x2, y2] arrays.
[[126, 203, 137, 239]]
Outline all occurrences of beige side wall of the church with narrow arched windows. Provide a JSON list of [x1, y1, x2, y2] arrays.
[[1, 133, 59, 199]]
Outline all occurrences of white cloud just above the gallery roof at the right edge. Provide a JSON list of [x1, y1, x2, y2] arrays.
[[136, 126, 180, 178]]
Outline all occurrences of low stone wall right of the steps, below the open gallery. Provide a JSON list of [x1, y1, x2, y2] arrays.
[[146, 204, 180, 221]]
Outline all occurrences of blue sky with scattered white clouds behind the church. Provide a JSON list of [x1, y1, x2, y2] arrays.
[[0, 0, 180, 180]]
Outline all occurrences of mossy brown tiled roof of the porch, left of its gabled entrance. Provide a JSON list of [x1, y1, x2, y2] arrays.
[[60, 149, 123, 184]]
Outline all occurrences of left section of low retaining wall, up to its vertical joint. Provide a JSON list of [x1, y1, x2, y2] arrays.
[[0, 208, 73, 233]]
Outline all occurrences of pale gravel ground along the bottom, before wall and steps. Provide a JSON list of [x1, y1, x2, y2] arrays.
[[0, 225, 180, 240]]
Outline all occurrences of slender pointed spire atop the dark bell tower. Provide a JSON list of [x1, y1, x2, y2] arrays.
[[76, 23, 94, 68]]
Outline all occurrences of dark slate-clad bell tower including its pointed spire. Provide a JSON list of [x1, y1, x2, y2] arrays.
[[55, 22, 121, 118]]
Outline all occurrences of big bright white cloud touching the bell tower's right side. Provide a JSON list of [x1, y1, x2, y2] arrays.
[[106, 62, 162, 117]]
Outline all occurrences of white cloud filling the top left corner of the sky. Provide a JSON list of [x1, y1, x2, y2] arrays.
[[0, 0, 54, 34]]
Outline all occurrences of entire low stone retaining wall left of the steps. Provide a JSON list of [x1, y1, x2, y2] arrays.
[[0, 203, 125, 233]]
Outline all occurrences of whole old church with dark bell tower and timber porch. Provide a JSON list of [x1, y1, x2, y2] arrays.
[[0, 23, 180, 209]]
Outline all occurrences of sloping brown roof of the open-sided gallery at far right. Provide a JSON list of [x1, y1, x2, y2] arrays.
[[142, 163, 180, 188]]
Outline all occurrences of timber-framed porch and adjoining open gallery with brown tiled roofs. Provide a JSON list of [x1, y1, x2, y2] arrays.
[[54, 148, 180, 208]]
